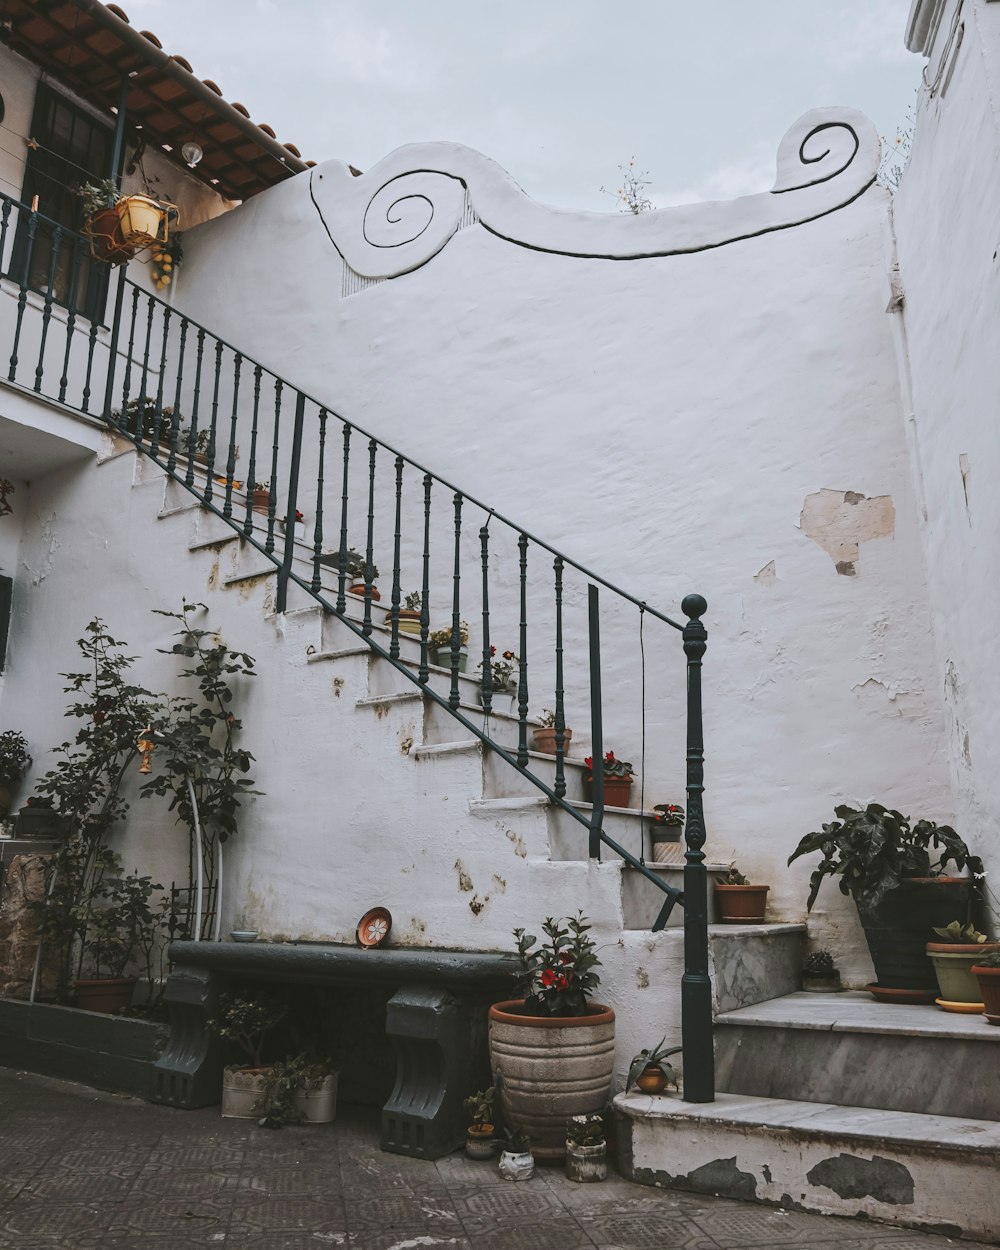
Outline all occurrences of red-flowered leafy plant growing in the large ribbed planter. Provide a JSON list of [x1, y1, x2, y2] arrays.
[[514, 913, 600, 1016]]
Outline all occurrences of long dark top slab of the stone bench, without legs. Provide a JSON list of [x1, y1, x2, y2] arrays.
[[170, 941, 521, 990]]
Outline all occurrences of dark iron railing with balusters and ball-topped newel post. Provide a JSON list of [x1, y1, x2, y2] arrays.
[[0, 196, 714, 1101]]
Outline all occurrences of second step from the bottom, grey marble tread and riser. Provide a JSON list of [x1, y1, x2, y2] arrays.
[[715, 993, 1000, 1120]]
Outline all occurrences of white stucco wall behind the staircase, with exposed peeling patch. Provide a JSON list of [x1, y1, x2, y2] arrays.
[[160, 115, 955, 978]]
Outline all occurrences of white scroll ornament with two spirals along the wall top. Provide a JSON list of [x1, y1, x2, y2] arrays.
[[310, 109, 880, 279]]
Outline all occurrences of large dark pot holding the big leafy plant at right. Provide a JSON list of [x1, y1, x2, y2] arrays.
[[859, 876, 973, 998]]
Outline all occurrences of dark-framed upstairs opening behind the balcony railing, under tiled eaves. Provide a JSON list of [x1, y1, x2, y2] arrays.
[[6, 83, 114, 321]]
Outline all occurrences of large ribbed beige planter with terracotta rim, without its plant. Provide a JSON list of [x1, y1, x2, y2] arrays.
[[490, 999, 615, 1160]]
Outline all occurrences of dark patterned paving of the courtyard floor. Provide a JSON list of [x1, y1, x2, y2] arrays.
[[0, 1069, 978, 1250]]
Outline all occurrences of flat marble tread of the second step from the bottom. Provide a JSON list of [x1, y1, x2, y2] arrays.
[[716, 990, 1000, 1043]]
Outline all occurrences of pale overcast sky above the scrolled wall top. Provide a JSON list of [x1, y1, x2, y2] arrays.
[[123, 0, 923, 211]]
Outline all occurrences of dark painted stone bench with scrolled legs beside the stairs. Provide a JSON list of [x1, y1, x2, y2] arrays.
[[153, 941, 520, 1159]]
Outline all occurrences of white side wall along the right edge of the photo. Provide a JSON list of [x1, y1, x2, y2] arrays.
[[894, 0, 1000, 870]]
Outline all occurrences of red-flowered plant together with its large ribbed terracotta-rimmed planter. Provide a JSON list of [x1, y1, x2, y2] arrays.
[[489, 914, 615, 1160]]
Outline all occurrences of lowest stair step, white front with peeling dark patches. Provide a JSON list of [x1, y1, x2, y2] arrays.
[[614, 1090, 1000, 1246]]
